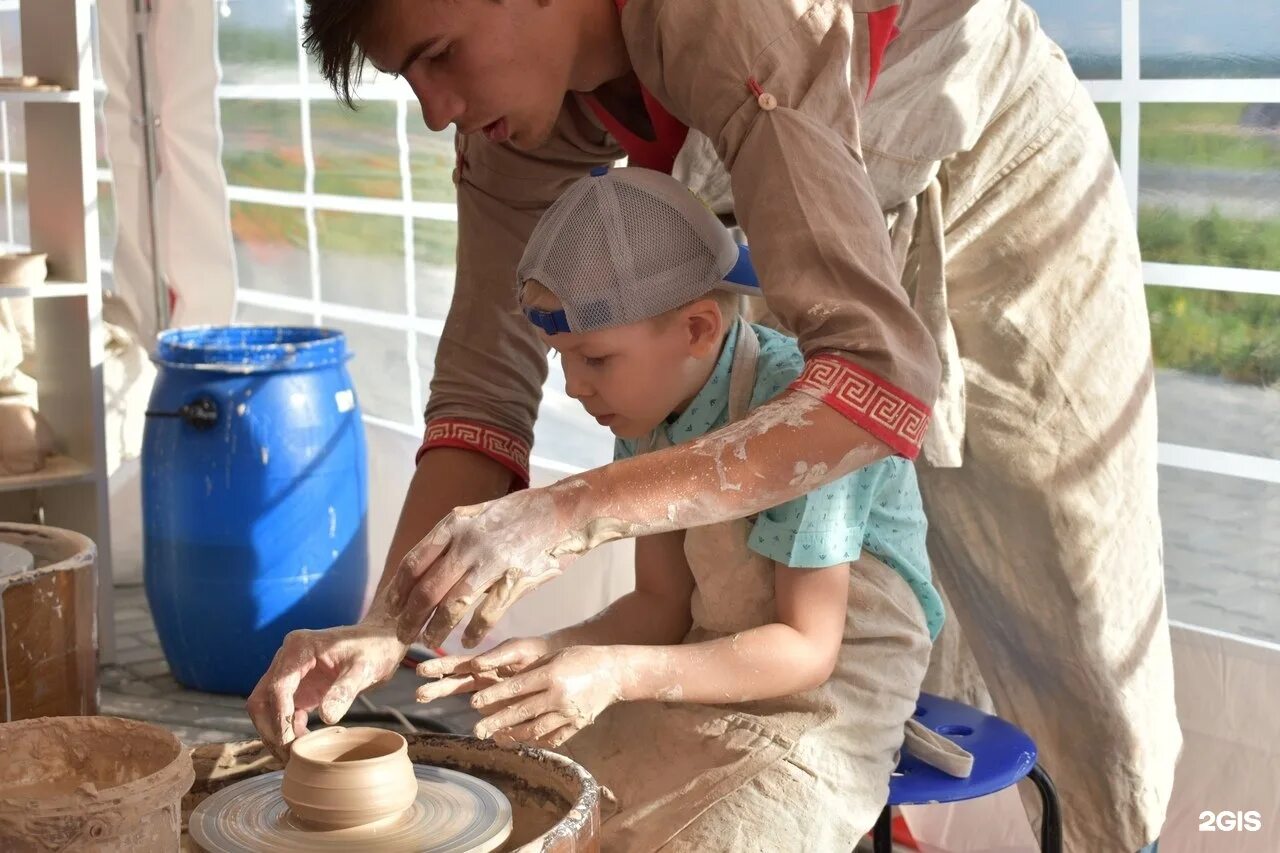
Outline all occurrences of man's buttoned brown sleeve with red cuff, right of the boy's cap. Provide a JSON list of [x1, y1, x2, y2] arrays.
[[622, 0, 941, 459]]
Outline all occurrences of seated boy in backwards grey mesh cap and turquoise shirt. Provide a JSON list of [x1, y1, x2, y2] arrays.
[[419, 169, 942, 853]]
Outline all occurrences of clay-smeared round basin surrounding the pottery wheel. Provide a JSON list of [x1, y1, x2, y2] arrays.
[[182, 734, 600, 853]]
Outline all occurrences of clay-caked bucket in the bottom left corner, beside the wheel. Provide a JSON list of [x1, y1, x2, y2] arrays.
[[0, 717, 195, 853]]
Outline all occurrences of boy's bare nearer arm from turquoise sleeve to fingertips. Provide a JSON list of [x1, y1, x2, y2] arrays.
[[460, 564, 849, 747]]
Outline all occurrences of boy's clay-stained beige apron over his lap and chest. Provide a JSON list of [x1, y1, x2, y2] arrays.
[[564, 323, 929, 853]]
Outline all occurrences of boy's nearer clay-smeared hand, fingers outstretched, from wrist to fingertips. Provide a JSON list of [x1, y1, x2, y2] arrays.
[[471, 646, 626, 749]]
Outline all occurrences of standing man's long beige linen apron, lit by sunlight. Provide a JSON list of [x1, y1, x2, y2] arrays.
[[732, 3, 1181, 853]]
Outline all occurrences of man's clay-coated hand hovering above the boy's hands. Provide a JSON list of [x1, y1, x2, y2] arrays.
[[389, 482, 641, 647]]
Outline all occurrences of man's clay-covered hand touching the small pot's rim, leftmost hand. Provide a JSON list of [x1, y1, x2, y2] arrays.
[[244, 613, 408, 761]]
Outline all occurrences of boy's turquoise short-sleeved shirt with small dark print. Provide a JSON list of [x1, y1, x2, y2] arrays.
[[614, 320, 943, 637]]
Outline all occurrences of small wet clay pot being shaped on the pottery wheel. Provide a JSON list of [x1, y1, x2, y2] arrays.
[[280, 726, 417, 829]]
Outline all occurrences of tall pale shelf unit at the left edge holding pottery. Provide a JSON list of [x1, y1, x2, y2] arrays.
[[0, 0, 115, 662]]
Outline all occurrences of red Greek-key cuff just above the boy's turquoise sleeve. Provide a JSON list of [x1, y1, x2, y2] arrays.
[[790, 352, 929, 459]]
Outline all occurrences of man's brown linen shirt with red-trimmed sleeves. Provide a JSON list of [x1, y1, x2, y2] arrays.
[[426, 0, 977, 471]]
